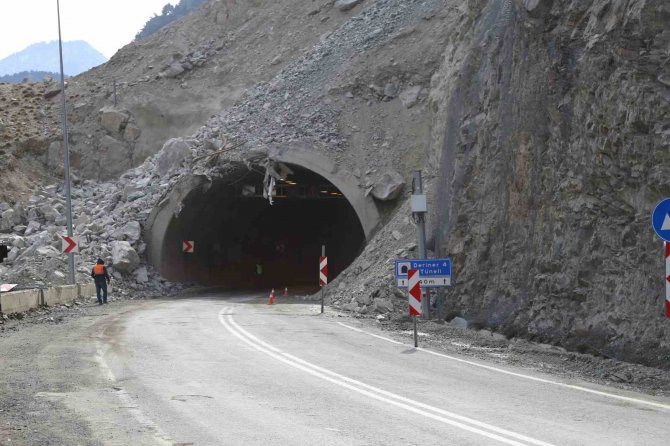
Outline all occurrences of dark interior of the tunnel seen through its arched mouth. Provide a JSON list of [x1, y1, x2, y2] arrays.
[[161, 165, 365, 292]]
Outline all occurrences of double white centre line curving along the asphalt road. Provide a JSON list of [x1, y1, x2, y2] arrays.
[[219, 308, 552, 446]]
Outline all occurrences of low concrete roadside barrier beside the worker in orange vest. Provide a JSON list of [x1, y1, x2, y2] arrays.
[[0, 283, 109, 314]]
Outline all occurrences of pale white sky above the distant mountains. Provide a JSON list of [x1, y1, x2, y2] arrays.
[[0, 0, 178, 59]]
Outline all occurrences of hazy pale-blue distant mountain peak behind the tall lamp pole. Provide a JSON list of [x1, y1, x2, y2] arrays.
[[0, 40, 107, 76]]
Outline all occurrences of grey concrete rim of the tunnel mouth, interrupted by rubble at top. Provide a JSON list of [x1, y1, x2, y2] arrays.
[[145, 147, 380, 286]]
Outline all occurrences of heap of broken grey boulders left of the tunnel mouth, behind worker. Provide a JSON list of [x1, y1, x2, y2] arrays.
[[0, 155, 186, 295]]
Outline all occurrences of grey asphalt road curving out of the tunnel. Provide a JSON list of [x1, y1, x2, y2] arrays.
[[69, 296, 670, 446]]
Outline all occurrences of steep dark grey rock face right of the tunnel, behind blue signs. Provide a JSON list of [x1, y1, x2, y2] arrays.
[[431, 0, 670, 365]]
